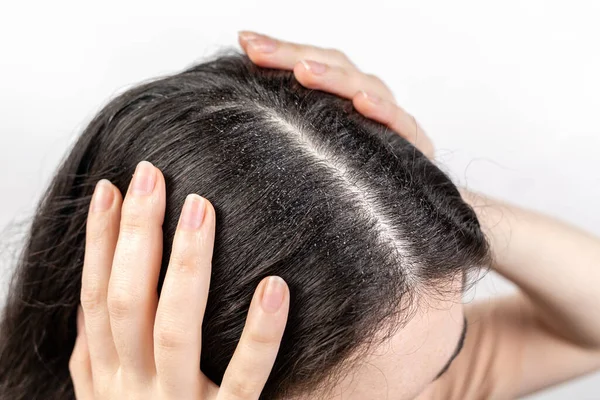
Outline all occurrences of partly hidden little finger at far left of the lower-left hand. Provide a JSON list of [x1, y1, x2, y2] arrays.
[[69, 307, 94, 400]]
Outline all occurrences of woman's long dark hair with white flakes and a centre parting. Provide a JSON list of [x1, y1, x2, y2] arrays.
[[0, 54, 488, 400]]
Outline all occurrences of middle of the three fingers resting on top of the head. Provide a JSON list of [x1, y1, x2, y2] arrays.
[[294, 60, 395, 102]]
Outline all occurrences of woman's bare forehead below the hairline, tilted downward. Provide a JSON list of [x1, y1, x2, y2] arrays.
[[312, 280, 465, 400]]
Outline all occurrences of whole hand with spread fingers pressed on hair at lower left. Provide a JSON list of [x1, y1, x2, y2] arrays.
[[69, 162, 289, 400]]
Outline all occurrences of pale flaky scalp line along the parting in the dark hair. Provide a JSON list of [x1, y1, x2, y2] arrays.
[[258, 106, 417, 284]]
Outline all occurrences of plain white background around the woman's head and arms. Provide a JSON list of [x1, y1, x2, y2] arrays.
[[0, 0, 600, 400]]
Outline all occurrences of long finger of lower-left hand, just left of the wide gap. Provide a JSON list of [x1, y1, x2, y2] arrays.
[[154, 194, 215, 399]]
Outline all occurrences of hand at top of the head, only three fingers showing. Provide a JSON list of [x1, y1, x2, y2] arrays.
[[239, 31, 434, 159]]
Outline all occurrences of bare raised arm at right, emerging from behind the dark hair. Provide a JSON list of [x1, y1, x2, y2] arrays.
[[462, 191, 600, 348]]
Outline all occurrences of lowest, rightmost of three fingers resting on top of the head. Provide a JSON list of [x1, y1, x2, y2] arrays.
[[352, 91, 434, 158]]
